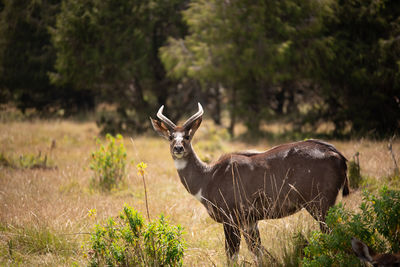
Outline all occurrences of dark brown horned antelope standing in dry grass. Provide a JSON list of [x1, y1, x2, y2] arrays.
[[150, 103, 349, 261]]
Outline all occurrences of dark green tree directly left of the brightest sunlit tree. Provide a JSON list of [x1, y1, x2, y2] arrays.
[[51, 0, 185, 132]]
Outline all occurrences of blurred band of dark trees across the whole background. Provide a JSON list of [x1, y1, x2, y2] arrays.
[[0, 0, 400, 137]]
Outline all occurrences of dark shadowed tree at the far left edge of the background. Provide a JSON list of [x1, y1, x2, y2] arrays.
[[0, 0, 93, 112]]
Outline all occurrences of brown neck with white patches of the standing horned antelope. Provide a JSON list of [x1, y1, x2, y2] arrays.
[[174, 146, 210, 198]]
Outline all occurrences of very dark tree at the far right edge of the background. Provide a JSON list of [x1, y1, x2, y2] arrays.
[[314, 0, 400, 136]]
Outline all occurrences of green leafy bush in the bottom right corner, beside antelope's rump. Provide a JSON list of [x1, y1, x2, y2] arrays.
[[302, 187, 400, 266]]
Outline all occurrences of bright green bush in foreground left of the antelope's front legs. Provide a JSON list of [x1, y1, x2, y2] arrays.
[[89, 205, 185, 266]]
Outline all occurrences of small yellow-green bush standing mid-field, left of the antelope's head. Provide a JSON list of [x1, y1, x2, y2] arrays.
[[90, 134, 127, 191]]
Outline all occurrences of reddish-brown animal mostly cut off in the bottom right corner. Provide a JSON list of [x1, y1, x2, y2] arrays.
[[351, 237, 400, 267]]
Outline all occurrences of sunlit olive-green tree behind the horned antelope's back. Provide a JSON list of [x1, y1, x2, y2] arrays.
[[161, 0, 321, 133]]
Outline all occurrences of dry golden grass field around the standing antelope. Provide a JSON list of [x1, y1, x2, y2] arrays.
[[0, 120, 400, 266]]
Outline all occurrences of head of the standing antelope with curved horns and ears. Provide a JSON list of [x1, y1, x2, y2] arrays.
[[150, 103, 204, 159]]
